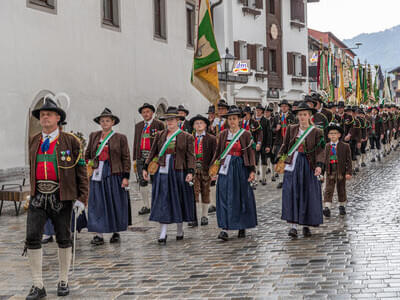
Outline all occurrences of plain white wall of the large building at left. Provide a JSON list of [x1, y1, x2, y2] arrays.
[[0, 0, 208, 169]]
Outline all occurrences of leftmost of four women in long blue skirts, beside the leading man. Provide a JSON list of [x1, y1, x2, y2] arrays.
[[85, 108, 131, 245]]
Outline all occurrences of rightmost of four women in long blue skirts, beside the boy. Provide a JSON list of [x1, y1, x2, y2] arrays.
[[278, 102, 325, 238]]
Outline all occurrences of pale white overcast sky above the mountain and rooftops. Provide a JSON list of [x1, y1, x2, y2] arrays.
[[308, 0, 400, 39]]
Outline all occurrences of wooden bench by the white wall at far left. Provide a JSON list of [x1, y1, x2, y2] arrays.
[[0, 172, 30, 216]]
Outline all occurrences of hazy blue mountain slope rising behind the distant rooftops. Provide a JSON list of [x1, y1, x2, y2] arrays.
[[343, 25, 400, 71]]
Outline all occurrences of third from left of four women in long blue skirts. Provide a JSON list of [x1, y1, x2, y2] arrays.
[[212, 105, 257, 241]]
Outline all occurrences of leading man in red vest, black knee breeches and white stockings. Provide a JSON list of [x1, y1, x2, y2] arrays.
[[25, 96, 88, 300]]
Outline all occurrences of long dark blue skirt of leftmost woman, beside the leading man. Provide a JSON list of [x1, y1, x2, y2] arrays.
[[88, 161, 128, 233]]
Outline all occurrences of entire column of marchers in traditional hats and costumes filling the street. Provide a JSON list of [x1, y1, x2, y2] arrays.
[[24, 93, 400, 299]]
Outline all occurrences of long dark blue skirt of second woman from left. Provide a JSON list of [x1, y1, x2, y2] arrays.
[[150, 156, 195, 224]]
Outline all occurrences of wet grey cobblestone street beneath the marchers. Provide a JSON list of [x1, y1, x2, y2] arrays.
[[0, 152, 400, 299]]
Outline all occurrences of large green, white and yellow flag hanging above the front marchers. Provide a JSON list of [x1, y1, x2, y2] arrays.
[[191, 0, 221, 104]]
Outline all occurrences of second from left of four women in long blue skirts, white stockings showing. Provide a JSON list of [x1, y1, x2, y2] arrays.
[[143, 106, 195, 245]]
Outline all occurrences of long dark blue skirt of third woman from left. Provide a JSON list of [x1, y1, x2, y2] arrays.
[[217, 156, 257, 230]]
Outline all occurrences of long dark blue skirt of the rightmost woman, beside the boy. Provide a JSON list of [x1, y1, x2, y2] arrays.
[[282, 153, 323, 226]]
